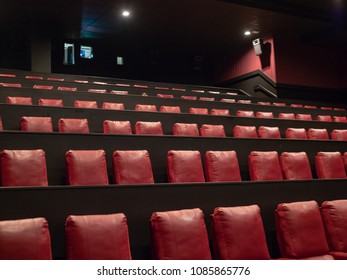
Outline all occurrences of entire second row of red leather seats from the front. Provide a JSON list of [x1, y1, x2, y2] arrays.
[[0, 150, 347, 186]]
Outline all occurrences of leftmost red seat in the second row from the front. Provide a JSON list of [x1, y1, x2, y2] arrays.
[[0, 150, 48, 187]]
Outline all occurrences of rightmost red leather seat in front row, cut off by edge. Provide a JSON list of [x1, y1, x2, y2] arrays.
[[321, 199, 347, 260]]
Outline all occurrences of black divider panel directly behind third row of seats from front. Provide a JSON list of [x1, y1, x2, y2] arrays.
[[0, 104, 347, 138]]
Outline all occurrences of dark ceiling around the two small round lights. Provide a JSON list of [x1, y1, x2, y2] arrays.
[[0, 0, 347, 52]]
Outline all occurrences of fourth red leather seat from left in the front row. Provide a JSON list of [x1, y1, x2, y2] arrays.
[[211, 205, 270, 260]]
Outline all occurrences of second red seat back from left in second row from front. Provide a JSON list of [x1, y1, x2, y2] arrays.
[[65, 150, 108, 186]]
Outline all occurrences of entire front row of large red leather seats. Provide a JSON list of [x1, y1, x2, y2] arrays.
[[0, 200, 347, 260]]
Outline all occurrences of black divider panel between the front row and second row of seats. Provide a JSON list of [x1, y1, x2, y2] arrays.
[[0, 179, 347, 259]]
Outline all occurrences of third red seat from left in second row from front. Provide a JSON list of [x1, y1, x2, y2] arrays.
[[112, 150, 154, 184]]
